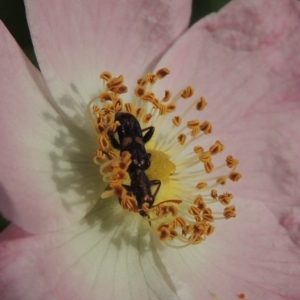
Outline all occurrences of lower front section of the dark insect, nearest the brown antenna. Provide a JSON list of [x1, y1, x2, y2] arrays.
[[123, 169, 161, 217]]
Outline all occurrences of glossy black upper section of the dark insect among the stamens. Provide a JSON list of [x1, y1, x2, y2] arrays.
[[108, 112, 155, 173]]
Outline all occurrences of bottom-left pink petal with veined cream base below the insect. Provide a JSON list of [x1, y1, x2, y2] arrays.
[[0, 199, 178, 300]]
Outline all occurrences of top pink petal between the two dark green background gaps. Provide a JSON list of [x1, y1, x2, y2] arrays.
[[25, 0, 191, 126]]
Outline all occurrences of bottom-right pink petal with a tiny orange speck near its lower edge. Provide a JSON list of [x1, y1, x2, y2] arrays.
[[157, 199, 300, 300]]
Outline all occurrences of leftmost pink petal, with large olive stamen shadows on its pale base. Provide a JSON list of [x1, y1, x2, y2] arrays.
[[0, 23, 105, 232]]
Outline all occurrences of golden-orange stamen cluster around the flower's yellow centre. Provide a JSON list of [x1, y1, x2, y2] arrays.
[[88, 68, 243, 248]]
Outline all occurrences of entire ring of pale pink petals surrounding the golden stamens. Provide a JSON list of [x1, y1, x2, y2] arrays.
[[0, 0, 300, 299]]
